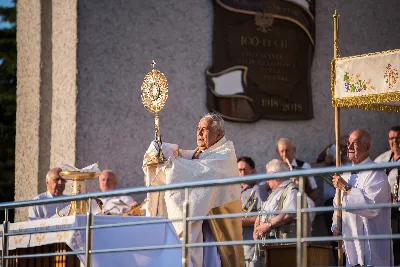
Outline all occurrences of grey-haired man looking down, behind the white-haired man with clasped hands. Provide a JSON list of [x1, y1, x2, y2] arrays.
[[276, 137, 318, 201]]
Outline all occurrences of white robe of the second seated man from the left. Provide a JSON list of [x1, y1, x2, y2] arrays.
[[92, 196, 138, 215]]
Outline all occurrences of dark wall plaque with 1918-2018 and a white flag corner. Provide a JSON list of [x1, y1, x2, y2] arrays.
[[206, 0, 315, 121]]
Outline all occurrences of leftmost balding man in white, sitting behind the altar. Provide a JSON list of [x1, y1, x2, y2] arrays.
[[28, 168, 69, 220]]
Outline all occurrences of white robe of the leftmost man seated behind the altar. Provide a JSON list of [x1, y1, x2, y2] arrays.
[[28, 191, 70, 221]]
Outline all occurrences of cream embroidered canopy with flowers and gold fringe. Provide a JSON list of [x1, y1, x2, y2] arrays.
[[332, 49, 400, 112]]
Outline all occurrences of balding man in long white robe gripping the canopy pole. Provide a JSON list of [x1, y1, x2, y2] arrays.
[[332, 130, 393, 266]]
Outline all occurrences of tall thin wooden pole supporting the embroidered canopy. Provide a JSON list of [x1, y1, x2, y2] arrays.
[[332, 10, 343, 266]]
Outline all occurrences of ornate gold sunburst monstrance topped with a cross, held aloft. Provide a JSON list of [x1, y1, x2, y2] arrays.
[[141, 60, 168, 166]]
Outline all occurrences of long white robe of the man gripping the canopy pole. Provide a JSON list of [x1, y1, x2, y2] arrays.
[[332, 157, 393, 266]]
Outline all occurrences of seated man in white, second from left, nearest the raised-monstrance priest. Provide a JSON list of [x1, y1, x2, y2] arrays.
[[93, 170, 137, 215]]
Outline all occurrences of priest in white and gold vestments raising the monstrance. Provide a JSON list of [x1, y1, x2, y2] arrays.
[[143, 114, 244, 267]]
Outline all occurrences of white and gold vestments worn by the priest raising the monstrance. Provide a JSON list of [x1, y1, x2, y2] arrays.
[[143, 137, 244, 267]]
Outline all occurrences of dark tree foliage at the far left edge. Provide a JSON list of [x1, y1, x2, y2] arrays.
[[0, 2, 17, 221]]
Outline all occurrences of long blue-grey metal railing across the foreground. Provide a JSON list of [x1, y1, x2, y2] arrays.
[[0, 162, 400, 266]]
